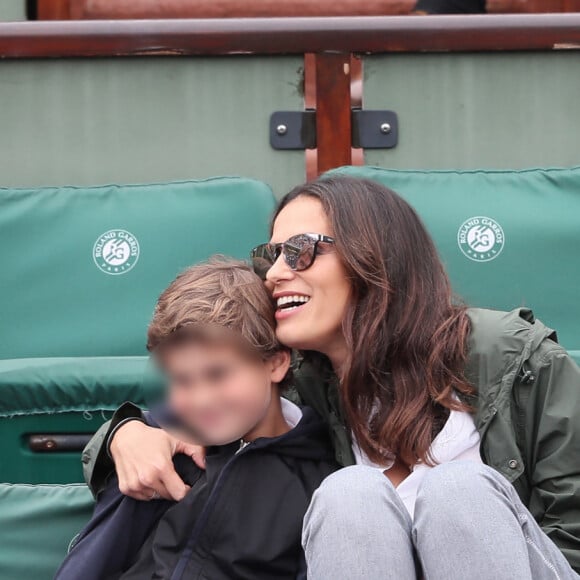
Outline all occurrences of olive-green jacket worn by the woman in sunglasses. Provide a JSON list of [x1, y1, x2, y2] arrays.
[[83, 308, 580, 572]]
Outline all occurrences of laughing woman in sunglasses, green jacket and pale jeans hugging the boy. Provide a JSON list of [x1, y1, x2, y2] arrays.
[[85, 176, 580, 580]]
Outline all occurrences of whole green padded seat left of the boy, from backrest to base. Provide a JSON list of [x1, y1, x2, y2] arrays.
[[0, 177, 274, 580]]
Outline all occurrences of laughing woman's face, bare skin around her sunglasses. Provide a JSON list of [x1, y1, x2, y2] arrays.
[[266, 195, 350, 367]]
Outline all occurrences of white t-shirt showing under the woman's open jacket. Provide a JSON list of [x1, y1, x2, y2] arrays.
[[352, 411, 483, 519]]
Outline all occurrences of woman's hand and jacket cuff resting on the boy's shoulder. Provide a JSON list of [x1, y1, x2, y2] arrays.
[[82, 403, 205, 501]]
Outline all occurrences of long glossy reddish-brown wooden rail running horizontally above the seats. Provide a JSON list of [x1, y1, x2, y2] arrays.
[[0, 14, 580, 58]]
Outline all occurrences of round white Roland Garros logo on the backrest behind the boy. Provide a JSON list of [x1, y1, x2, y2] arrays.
[[93, 230, 139, 276]]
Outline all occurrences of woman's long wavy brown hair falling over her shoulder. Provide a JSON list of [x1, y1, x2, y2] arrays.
[[274, 175, 472, 465]]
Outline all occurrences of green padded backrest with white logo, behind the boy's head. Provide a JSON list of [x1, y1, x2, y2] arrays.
[[0, 177, 274, 359]]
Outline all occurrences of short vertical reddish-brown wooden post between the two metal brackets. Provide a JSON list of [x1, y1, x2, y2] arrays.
[[316, 53, 352, 174]]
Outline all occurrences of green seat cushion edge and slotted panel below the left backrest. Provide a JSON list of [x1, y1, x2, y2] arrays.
[[0, 357, 155, 482]]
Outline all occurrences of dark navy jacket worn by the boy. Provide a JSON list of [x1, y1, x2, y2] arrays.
[[56, 403, 338, 580]]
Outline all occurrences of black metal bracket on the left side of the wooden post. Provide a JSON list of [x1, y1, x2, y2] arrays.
[[270, 109, 316, 149]]
